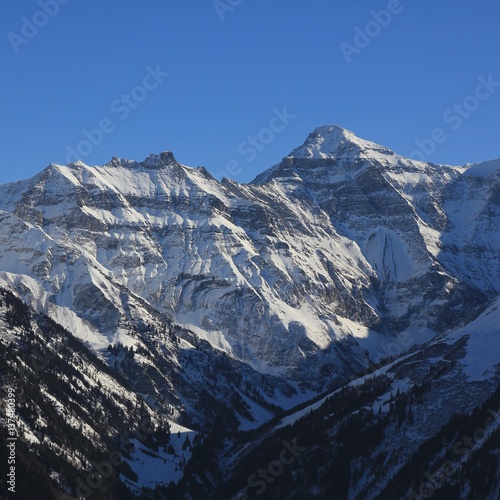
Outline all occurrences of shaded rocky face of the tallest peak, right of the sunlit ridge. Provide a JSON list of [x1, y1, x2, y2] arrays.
[[256, 127, 488, 336]]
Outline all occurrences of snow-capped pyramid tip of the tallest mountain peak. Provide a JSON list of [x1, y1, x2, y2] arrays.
[[288, 125, 387, 158]]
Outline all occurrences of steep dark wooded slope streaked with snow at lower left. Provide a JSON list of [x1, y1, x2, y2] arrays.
[[0, 289, 197, 499]]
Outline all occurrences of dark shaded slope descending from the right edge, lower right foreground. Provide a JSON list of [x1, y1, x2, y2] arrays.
[[215, 301, 500, 500]]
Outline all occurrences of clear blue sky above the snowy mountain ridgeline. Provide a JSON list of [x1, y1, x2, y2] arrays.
[[0, 0, 500, 183]]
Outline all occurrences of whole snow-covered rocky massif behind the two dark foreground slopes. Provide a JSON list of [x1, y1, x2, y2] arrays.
[[0, 126, 500, 491]]
